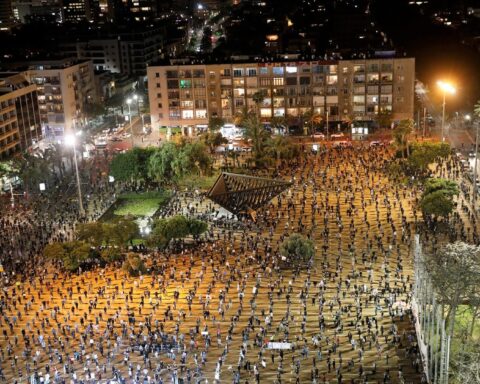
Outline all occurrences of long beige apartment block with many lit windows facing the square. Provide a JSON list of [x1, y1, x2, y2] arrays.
[[147, 58, 415, 134]]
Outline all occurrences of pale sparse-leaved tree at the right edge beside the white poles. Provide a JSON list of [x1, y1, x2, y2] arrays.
[[426, 241, 480, 336]]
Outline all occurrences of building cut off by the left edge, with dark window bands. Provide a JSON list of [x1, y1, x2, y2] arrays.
[[0, 73, 42, 160]]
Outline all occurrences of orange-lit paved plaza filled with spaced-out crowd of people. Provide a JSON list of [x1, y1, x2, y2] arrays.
[[0, 148, 428, 384]]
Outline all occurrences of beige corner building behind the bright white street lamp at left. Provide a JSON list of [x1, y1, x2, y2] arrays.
[[5, 58, 97, 137]]
